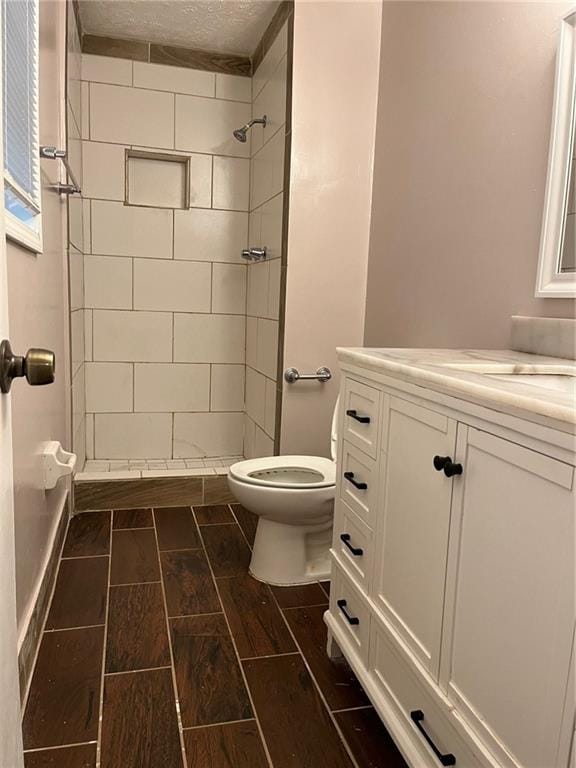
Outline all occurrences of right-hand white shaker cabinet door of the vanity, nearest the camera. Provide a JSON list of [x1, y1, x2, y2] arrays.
[[441, 425, 576, 768]]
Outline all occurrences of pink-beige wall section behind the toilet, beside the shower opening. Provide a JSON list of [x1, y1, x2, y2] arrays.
[[280, 0, 381, 456]]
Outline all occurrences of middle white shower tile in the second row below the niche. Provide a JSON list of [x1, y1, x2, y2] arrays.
[[134, 259, 212, 312]]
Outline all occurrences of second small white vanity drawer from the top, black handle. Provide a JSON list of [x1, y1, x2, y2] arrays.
[[337, 440, 378, 529]]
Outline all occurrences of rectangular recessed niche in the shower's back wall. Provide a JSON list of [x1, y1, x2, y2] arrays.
[[125, 149, 190, 208]]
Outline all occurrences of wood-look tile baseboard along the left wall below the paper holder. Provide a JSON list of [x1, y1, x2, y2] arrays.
[[18, 493, 70, 704]]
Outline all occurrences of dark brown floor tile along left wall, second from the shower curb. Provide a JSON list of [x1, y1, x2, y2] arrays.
[[46, 557, 110, 629]]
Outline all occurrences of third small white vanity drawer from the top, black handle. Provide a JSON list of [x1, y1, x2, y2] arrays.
[[332, 499, 373, 594]]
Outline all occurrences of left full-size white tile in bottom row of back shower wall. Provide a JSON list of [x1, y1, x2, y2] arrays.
[[94, 413, 172, 459]]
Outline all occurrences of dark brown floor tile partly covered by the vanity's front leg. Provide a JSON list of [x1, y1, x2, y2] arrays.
[[284, 606, 370, 709]]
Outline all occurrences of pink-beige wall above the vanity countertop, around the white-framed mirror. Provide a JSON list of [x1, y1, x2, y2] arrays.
[[364, 2, 575, 348]]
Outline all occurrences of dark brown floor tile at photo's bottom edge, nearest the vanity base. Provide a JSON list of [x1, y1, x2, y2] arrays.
[[335, 707, 408, 768]]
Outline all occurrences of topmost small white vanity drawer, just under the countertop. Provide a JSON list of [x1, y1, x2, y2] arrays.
[[343, 378, 382, 459]]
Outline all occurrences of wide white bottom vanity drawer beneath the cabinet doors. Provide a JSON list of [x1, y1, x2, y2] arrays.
[[368, 621, 486, 768]]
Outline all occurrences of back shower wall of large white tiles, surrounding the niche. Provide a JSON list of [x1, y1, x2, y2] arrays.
[[82, 54, 251, 460]]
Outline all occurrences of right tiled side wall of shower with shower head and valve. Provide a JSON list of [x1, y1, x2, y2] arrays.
[[244, 21, 291, 458]]
